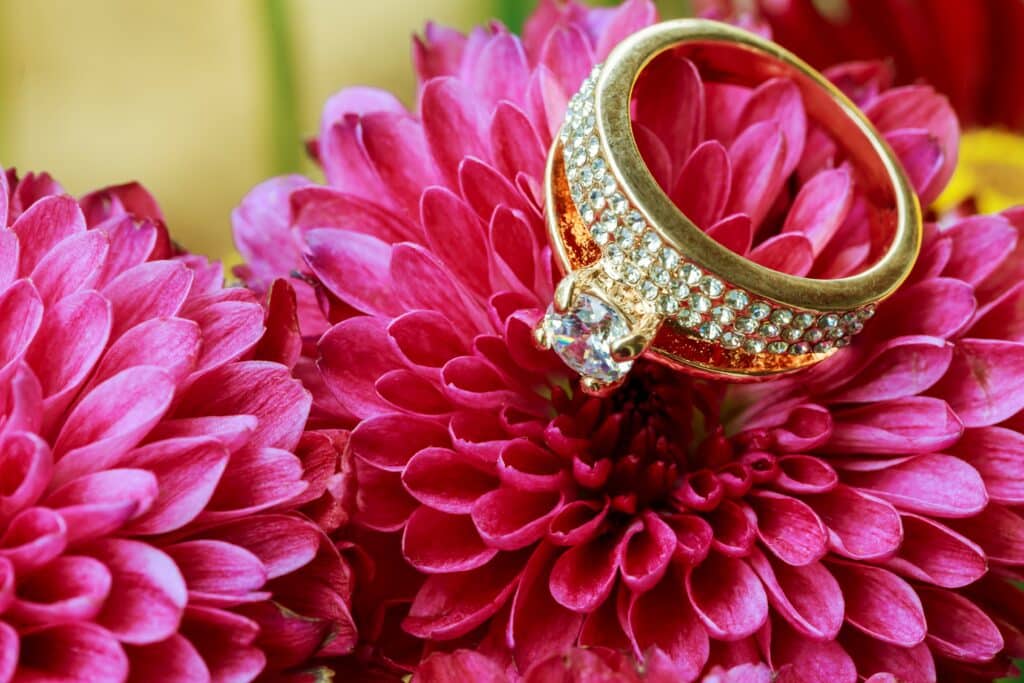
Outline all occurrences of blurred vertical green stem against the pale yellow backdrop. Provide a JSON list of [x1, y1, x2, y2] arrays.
[[260, 0, 302, 173]]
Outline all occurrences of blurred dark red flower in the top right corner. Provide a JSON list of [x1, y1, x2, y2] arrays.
[[712, 0, 1024, 130]]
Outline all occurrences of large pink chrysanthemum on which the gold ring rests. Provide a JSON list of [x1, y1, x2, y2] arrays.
[[236, 0, 1024, 683]]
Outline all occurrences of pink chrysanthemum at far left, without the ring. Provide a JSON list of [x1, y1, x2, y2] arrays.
[[0, 167, 354, 682]]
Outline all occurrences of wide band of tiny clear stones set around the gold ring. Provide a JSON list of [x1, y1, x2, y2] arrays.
[[560, 66, 874, 354]]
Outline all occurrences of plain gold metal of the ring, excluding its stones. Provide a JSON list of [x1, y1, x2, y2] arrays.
[[545, 19, 922, 379]]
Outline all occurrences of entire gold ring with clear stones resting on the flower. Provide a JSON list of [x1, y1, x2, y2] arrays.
[[535, 19, 922, 393]]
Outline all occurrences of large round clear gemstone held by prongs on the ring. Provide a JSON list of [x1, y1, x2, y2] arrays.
[[543, 294, 633, 383]]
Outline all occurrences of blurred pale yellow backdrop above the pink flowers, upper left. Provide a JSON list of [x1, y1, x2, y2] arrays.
[[0, 0, 689, 257]]
